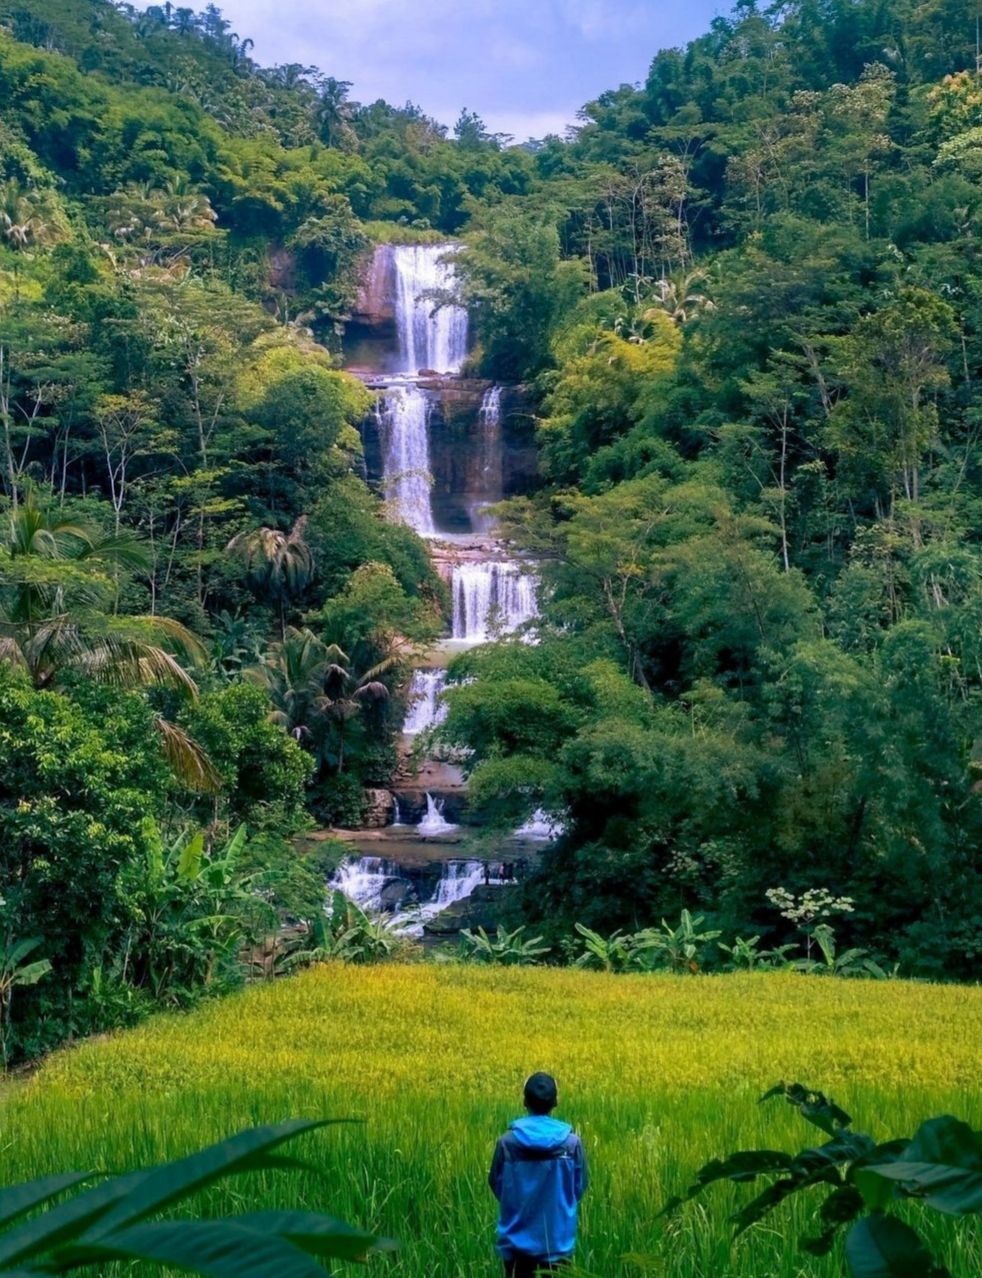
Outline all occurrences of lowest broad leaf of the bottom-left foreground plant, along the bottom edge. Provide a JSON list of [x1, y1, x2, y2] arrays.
[[67, 1220, 325, 1278]]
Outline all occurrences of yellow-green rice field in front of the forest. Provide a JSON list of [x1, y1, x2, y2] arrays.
[[0, 964, 982, 1278]]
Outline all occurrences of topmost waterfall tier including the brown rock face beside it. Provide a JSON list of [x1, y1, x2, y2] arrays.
[[345, 243, 468, 377]]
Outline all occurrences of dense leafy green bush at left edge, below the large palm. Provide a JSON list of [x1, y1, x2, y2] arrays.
[[0, 666, 169, 1057]]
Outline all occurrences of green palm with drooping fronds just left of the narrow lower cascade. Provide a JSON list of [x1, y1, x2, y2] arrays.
[[246, 626, 395, 772]]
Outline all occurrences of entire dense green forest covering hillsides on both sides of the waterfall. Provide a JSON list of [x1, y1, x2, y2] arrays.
[[0, 0, 982, 1061]]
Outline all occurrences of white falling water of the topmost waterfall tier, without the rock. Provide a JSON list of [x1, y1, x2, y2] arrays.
[[393, 244, 467, 373]]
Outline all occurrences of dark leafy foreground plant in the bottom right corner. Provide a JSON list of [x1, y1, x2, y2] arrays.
[[661, 1082, 982, 1278]]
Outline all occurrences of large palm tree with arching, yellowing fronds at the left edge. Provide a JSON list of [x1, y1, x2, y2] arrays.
[[0, 487, 217, 790]]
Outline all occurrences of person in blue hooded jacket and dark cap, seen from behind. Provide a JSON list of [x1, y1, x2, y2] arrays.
[[487, 1074, 587, 1278]]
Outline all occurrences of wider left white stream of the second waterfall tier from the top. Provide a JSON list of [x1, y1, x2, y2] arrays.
[[376, 382, 435, 534]]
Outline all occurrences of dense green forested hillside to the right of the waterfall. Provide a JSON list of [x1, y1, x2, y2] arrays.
[[444, 4, 982, 976]]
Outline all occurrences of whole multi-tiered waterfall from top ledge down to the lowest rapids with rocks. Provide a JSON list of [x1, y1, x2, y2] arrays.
[[334, 243, 554, 930]]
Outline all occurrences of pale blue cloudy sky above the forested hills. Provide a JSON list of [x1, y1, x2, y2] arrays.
[[184, 0, 730, 141]]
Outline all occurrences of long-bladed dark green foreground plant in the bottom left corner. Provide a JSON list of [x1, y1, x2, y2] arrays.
[[0, 1120, 391, 1278]]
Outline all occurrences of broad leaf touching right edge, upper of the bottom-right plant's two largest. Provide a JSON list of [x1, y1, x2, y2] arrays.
[[869, 1114, 982, 1215]]
